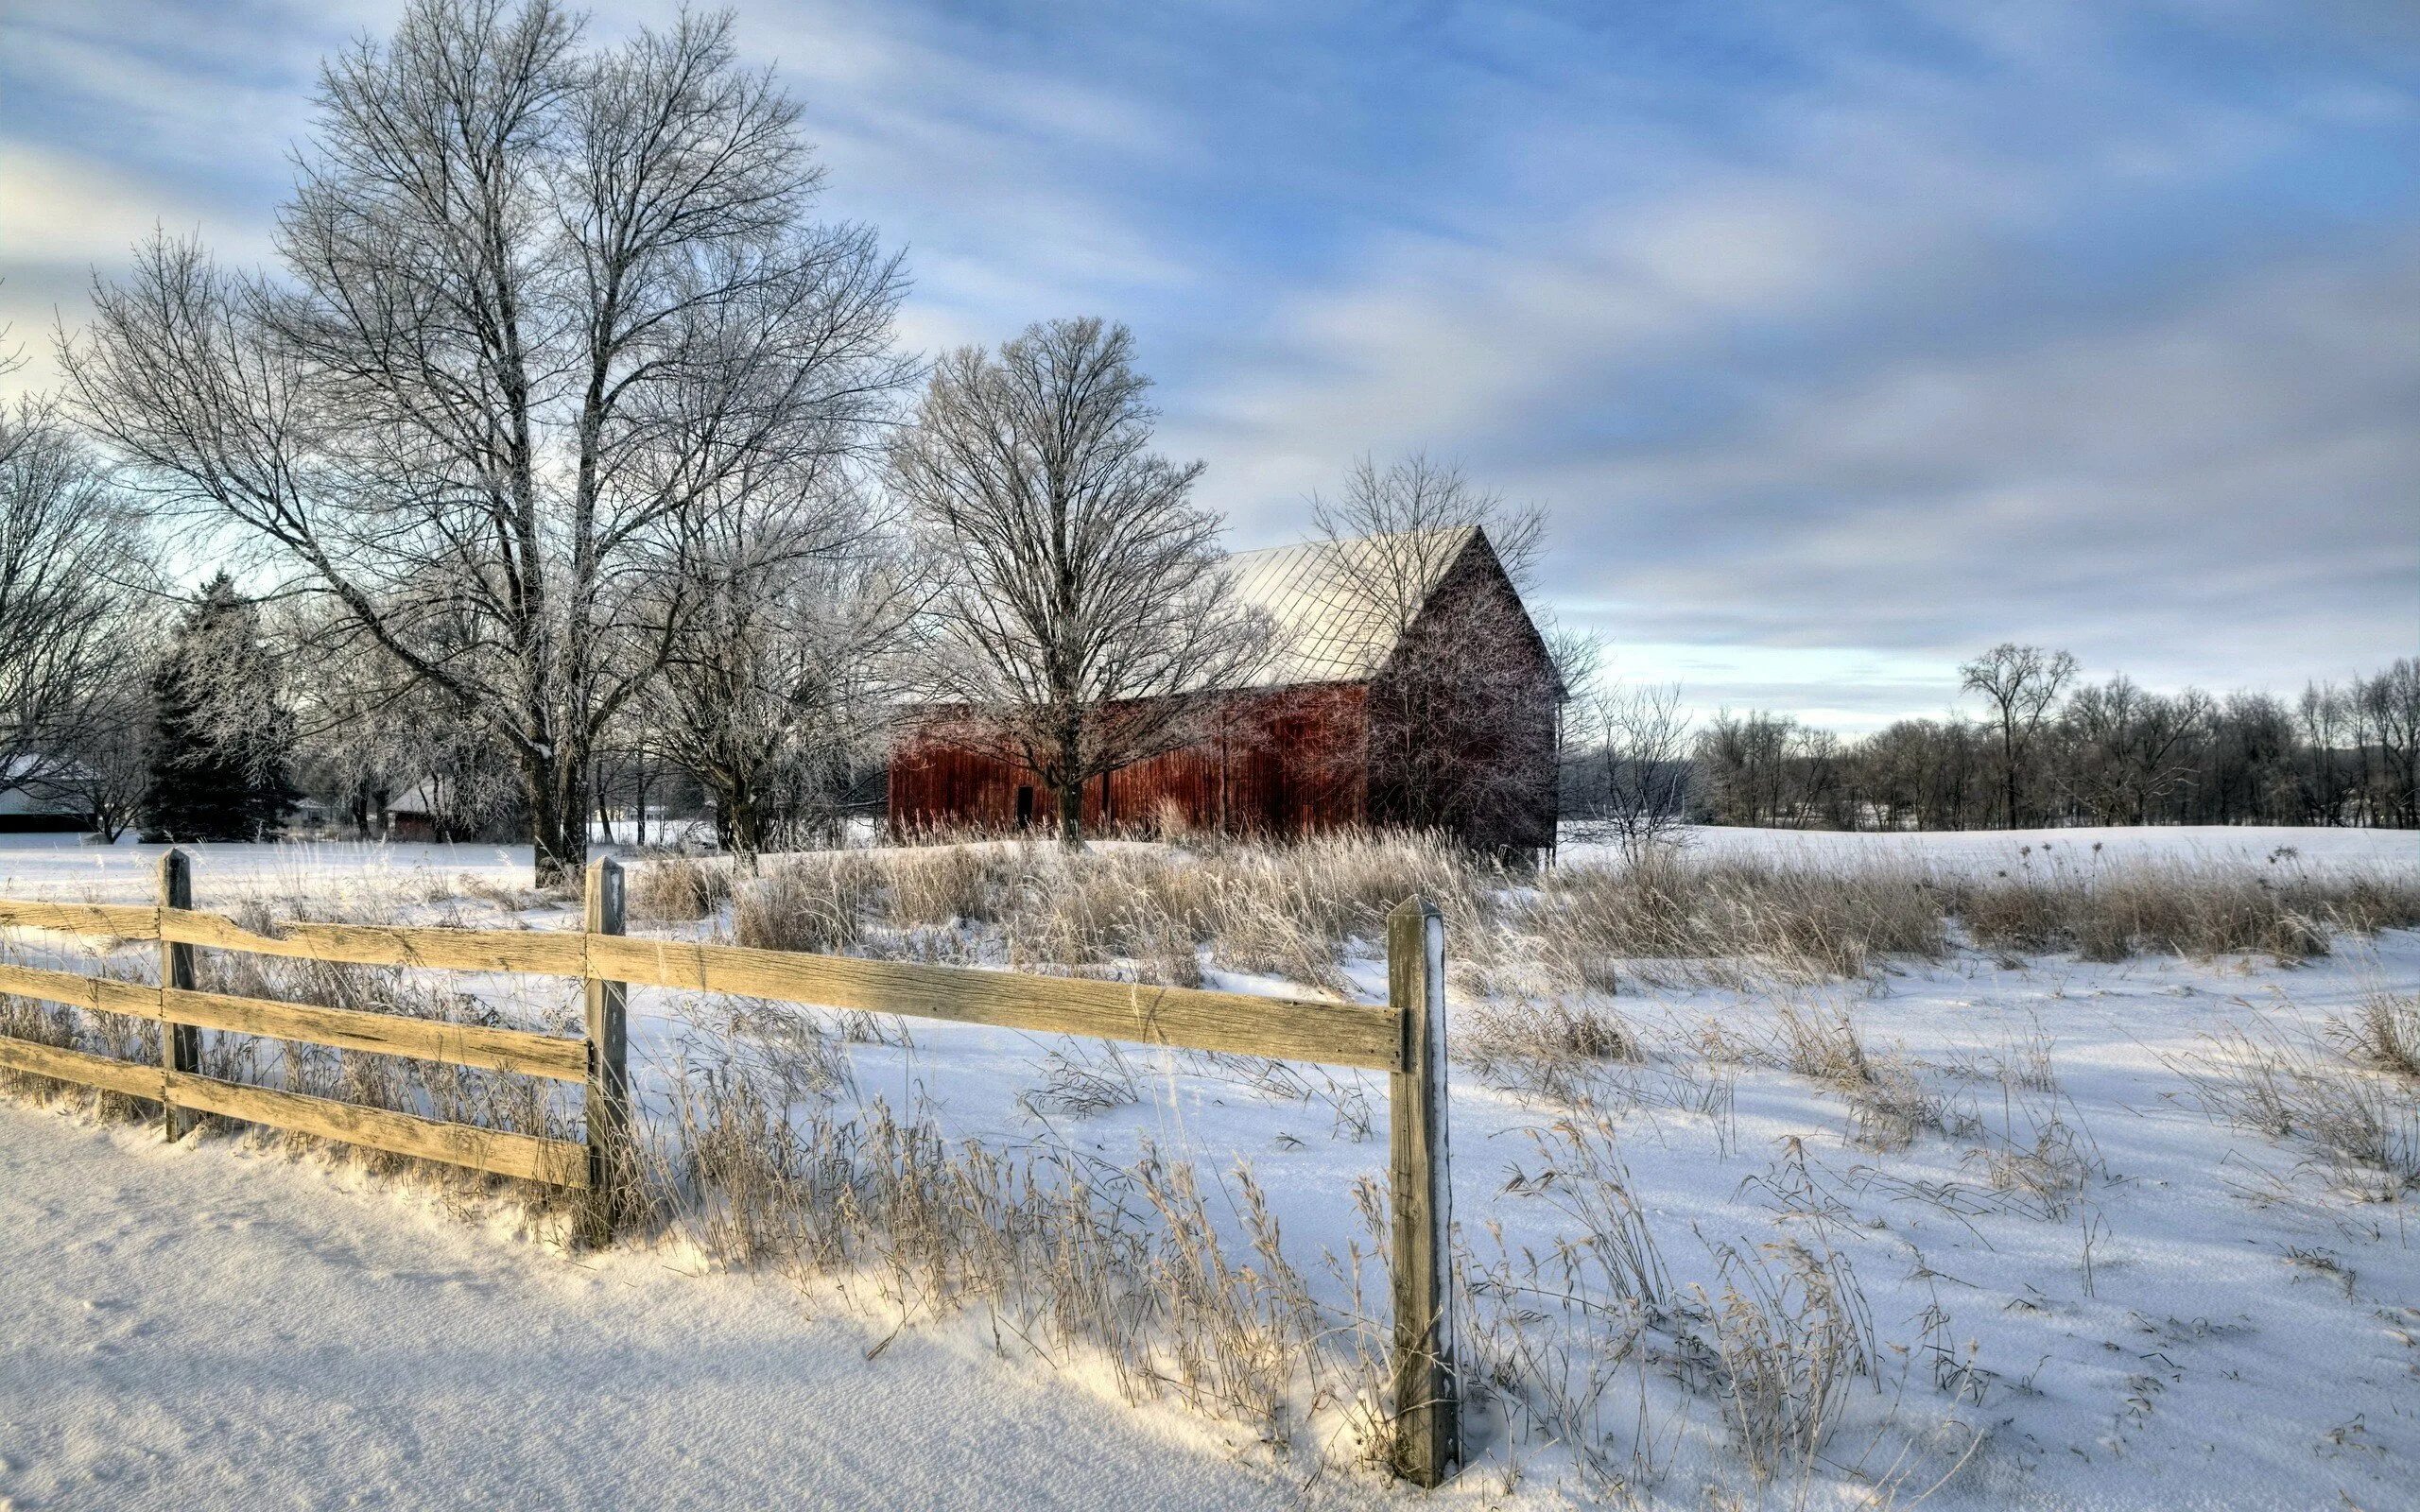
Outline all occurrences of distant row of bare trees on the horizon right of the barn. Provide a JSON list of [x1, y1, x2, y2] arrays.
[[1564, 644, 2420, 839]]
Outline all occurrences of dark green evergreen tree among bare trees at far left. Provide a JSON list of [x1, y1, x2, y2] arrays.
[[143, 574, 295, 839]]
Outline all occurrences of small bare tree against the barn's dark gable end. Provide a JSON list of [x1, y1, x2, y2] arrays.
[[1312, 453, 1582, 837]]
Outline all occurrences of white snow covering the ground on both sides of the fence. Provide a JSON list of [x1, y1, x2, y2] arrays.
[[0, 830, 2420, 1512]]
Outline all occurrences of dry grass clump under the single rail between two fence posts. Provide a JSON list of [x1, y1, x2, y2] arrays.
[[647, 1057, 1384, 1447]]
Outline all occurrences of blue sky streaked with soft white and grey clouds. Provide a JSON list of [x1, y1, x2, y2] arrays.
[[0, 0, 2420, 729]]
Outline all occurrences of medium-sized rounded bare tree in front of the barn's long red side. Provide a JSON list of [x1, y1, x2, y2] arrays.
[[890, 319, 1268, 844]]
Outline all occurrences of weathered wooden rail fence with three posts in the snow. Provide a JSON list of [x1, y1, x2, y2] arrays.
[[0, 850, 1460, 1486]]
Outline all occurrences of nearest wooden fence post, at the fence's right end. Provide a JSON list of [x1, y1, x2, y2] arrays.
[[1387, 898, 1461, 1486]]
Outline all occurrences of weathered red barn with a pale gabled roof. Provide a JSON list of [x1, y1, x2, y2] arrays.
[[889, 527, 1564, 851]]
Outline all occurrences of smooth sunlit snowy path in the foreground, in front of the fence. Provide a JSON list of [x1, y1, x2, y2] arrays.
[[0, 1103, 1377, 1512]]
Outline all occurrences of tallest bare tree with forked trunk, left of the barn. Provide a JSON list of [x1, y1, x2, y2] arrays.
[[63, 0, 905, 881]]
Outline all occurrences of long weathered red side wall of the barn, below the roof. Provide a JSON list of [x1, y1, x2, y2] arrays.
[[889, 684, 1367, 834]]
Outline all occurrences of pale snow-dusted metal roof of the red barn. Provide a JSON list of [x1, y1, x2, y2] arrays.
[[1227, 525, 1478, 687]]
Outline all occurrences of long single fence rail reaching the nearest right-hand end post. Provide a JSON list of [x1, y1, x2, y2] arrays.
[[588, 934, 1404, 1072]]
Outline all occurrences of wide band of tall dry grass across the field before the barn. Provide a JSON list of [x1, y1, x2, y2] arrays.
[[631, 833, 2420, 999]]
